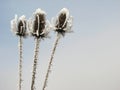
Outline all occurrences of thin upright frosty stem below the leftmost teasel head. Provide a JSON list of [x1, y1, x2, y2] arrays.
[[19, 36, 22, 90]]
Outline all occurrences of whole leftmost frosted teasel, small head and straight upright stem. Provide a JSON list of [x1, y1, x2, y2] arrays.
[[11, 15, 28, 90]]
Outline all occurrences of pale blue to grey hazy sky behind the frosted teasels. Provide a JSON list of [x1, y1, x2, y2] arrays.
[[0, 0, 120, 90]]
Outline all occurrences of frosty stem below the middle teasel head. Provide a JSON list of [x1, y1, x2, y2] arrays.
[[31, 38, 40, 90]]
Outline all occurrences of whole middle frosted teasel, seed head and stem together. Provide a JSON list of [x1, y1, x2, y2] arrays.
[[28, 8, 50, 90]]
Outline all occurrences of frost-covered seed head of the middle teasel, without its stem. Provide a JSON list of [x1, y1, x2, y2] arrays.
[[28, 8, 50, 38]]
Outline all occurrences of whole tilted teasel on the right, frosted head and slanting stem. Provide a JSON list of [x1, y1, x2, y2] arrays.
[[42, 8, 73, 90]]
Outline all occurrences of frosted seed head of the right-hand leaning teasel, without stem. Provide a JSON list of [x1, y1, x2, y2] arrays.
[[52, 8, 73, 36]]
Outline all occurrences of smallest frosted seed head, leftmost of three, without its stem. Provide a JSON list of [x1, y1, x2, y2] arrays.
[[11, 15, 27, 37]]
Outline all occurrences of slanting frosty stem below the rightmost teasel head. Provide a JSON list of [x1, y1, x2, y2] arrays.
[[42, 33, 60, 90]]
